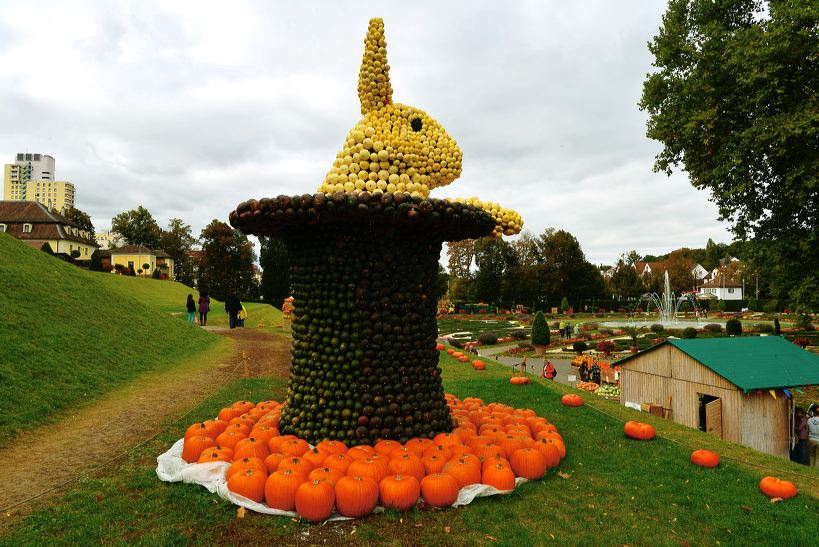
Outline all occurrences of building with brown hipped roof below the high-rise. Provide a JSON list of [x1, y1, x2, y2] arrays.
[[0, 201, 97, 260]]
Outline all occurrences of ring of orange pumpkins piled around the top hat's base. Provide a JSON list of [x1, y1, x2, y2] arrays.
[[182, 395, 566, 522]]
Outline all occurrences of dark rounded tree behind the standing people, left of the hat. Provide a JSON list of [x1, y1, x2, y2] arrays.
[[197, 219, 258, 300]]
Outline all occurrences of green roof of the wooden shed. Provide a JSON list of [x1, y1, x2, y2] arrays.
[[613, 336, 819, 393]]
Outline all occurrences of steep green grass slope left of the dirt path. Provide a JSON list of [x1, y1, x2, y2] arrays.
[[0, 234, 218, 442]]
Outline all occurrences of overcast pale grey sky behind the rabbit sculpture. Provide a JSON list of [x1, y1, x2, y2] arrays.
[[0, 0, 731, 263]]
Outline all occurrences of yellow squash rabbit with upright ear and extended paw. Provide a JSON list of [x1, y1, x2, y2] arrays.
[[319, 18, 523, 237]]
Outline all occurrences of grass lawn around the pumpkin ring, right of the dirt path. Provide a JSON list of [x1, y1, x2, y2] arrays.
[[0, 342, 819, 545]]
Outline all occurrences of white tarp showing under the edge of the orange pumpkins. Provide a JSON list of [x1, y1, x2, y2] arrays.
[[156, 439, 526, 520]]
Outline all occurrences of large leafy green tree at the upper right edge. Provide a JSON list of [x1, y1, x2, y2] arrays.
[[640, 0, 819, 307]]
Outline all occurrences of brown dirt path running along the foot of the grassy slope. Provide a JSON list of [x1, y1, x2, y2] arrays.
[[0, 327, 290, 527]]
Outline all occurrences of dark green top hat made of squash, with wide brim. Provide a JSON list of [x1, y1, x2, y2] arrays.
[[230, 192, 494, 446]]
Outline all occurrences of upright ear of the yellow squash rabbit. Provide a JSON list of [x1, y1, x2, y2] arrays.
[[358, 17, 392, 114]]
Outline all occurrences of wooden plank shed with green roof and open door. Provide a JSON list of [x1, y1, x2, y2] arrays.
[[614, 336, 819, 458]]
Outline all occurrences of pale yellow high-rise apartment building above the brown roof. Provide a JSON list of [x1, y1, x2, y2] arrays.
[[3, 153, 75, 212]]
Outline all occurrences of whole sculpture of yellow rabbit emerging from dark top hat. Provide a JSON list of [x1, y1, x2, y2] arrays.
[[227, 18, 523, 448]]
